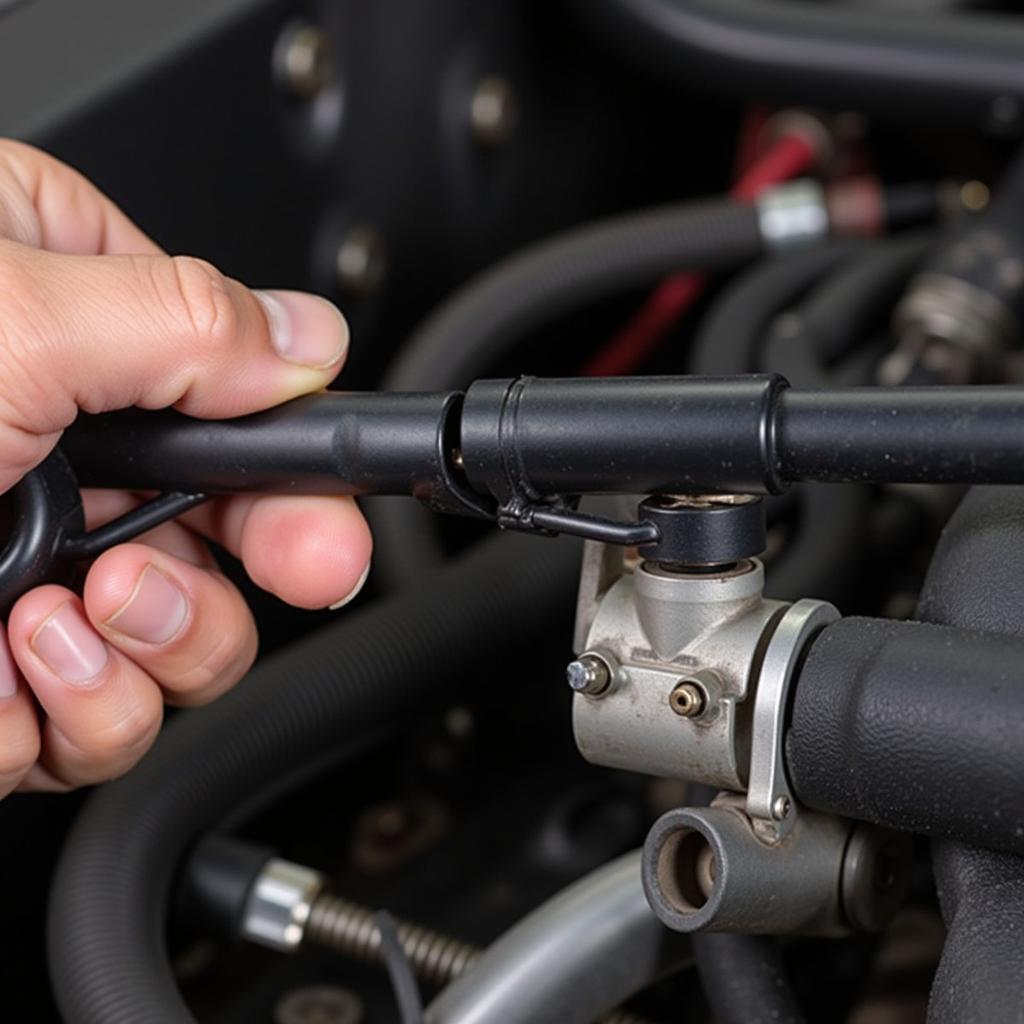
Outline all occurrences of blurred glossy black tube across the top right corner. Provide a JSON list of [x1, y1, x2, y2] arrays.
[[575, 0, 1024, 127]]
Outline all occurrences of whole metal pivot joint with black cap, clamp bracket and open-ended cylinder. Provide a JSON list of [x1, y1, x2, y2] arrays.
[[569, 496, 908, 935]]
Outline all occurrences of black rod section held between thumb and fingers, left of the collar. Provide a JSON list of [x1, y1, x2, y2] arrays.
[[60, 392, 459, 498]]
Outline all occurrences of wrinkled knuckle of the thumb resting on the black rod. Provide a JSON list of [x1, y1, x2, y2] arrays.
[[156, 256, 239, 357]]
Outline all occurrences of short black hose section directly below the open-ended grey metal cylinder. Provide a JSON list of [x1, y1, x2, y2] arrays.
[[692, 934, 804, 1024]]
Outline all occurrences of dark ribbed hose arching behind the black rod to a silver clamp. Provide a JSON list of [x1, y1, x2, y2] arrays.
[[366, 200, 762, 589]]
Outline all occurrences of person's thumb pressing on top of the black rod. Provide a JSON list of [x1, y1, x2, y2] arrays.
[[0, 241, 348, 492]]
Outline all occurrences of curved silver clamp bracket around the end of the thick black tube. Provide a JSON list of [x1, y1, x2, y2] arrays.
[[746, 599, 840, 843]]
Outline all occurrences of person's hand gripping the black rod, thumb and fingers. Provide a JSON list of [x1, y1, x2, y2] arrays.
[[0, 139, 371, 796]]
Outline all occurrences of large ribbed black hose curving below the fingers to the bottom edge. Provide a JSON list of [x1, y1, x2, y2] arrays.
[[47, 537, 579, 1024]]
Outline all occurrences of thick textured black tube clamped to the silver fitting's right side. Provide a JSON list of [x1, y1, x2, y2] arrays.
[[786, 618, 1024, 853]]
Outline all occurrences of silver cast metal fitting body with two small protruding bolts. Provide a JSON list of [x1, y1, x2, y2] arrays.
[[572, 545, 785, 790]]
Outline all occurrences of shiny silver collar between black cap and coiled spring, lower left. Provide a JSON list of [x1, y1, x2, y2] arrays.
[[242, 857, 324, 952]]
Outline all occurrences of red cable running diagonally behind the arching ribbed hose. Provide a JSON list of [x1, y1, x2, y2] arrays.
[[583, 135, 817, 377]]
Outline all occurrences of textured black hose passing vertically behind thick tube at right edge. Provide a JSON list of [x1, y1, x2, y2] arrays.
[[918, 487, 1024, 1024]]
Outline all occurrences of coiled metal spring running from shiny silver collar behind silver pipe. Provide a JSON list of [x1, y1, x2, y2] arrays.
[[304, 893, 645, 1024]]
